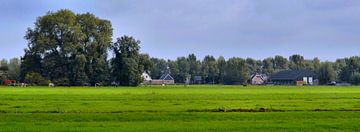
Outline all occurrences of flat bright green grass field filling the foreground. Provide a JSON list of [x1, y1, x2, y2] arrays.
[[0, 86, 360, 132]]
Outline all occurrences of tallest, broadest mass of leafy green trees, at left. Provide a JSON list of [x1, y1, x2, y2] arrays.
[[21, 10, 112, 85]]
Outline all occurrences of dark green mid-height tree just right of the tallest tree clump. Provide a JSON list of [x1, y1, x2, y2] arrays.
[[111, 36, 143, 86]]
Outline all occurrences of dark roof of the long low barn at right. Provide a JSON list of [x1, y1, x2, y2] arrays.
[[270, 69, 315, 80]]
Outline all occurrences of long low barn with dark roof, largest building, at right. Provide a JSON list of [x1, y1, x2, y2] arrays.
[[270, 69, 315, 85]]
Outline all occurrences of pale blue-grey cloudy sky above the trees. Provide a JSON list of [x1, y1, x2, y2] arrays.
[[0, 0, 360, 60]]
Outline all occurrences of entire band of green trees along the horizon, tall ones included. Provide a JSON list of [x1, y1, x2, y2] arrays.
[[0, 10, 360, 86]]
